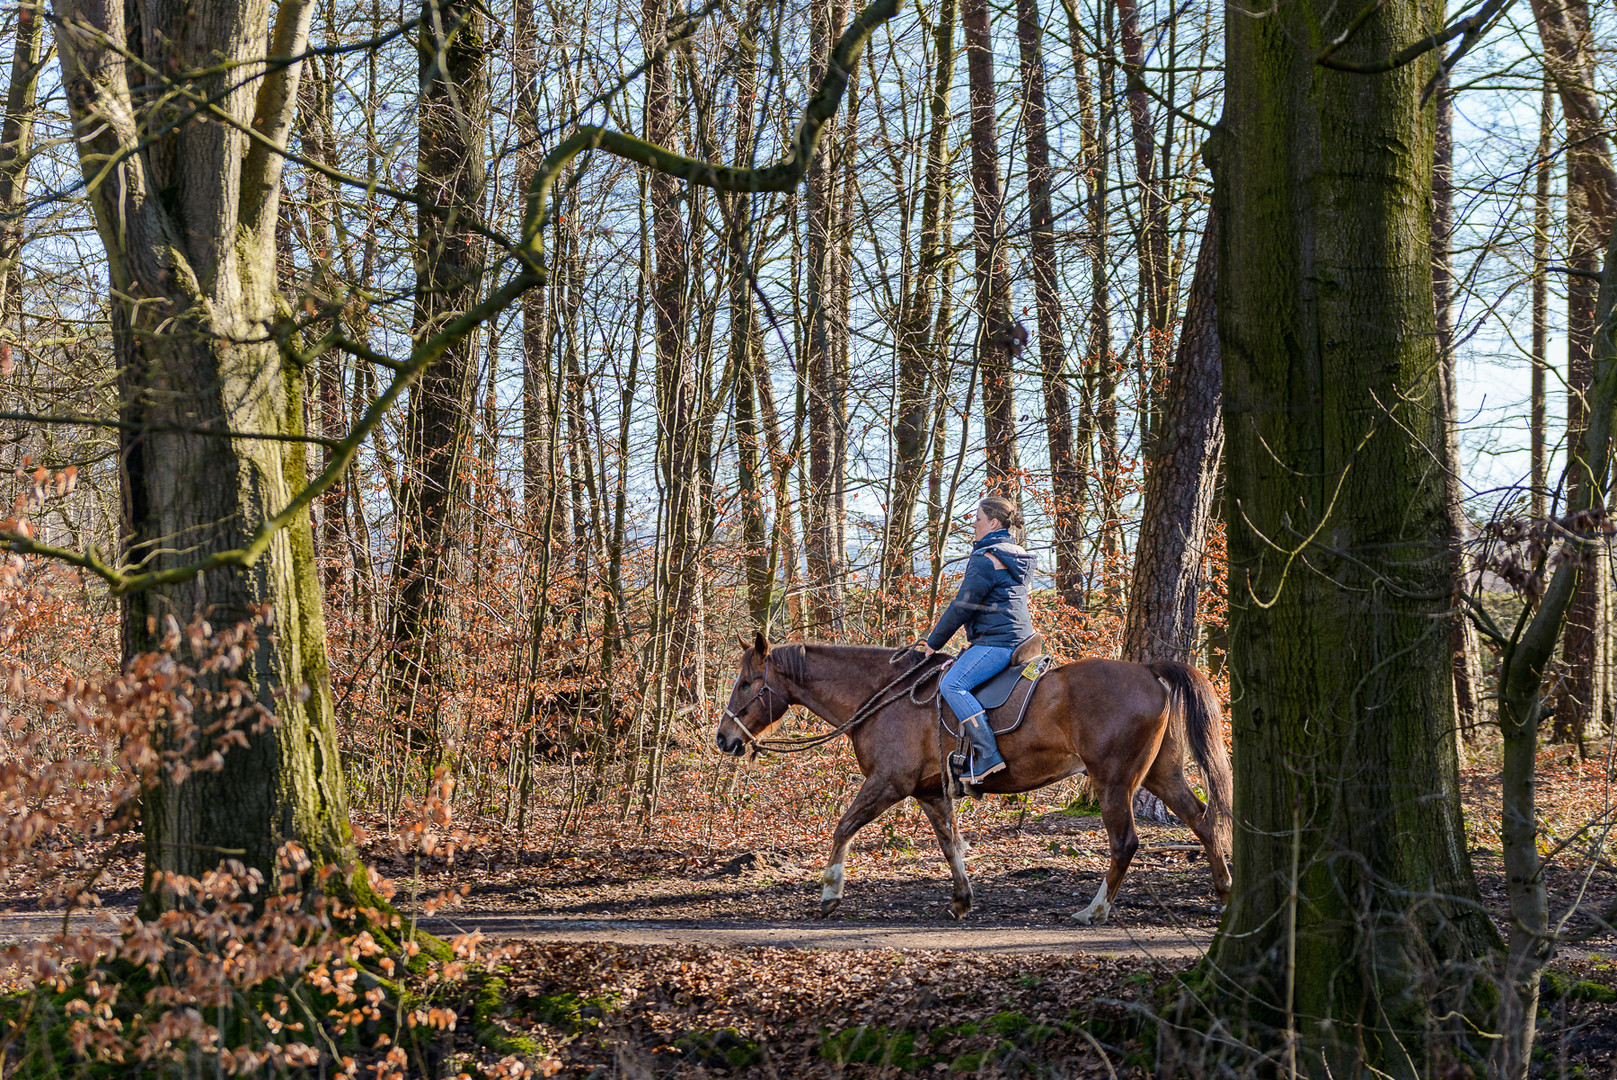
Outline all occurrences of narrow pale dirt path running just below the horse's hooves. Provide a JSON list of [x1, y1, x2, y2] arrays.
[[0, 909, 1213, 959]]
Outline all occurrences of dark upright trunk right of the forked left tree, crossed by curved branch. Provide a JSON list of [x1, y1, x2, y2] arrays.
[[393, 0, 488, 749]]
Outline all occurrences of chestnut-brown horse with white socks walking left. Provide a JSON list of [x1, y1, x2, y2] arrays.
[[715, 634, 1231, 923]]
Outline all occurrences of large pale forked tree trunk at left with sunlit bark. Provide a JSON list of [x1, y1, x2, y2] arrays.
[[57, 0, 364, 913]]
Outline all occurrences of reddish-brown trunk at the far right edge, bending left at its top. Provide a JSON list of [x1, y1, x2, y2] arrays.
[[1533, 0, 1617, 749]]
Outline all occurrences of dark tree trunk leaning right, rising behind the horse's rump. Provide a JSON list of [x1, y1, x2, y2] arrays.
[[1122, 212, 1224, 663]]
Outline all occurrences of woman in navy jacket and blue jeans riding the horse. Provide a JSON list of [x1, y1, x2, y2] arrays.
[[925, 495, 1038, 784]]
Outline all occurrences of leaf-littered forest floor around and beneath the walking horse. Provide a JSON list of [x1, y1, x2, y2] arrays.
[[0, 734, 1617, 1080]]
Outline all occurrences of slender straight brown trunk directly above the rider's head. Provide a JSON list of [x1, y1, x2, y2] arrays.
[[960, 0, 1022, 506]]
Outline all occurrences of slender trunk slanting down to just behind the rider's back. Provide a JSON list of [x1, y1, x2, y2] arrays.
[[1017, 0, 1083, 608]]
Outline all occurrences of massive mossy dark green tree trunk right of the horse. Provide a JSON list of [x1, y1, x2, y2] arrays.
[[1210, 0, 1497, 1080]]
